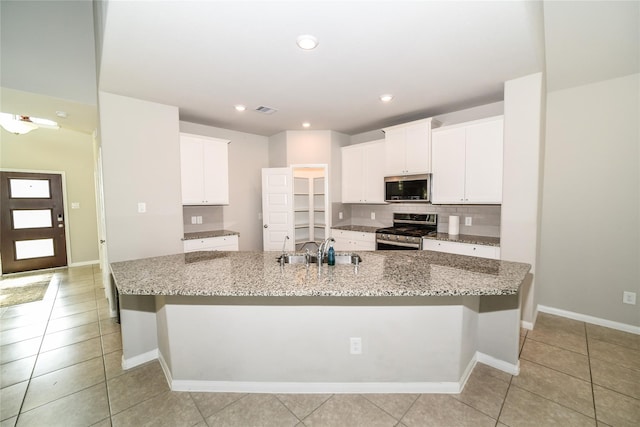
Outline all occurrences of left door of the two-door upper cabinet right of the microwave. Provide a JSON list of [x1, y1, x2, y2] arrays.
[[431, 127, 466, 204]]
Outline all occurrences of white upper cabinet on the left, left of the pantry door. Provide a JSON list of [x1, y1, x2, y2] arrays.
[[180, 133, 229, 205]]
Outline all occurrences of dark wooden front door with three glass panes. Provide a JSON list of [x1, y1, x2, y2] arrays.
[[0, 172, 67, 274]]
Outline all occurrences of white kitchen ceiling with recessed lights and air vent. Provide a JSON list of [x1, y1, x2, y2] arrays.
[[99, 0, 544, 135]]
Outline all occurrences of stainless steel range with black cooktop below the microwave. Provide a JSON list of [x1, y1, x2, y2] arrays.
[[376, 213, 438, 250]]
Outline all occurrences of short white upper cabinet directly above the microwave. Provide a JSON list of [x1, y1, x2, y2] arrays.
[[383, 118, 439, 176]]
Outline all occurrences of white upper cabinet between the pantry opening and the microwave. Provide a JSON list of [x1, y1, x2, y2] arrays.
[[341, 140, 384, 203]]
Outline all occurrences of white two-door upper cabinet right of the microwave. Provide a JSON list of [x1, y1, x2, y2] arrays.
[[431, 116, 504, 204]]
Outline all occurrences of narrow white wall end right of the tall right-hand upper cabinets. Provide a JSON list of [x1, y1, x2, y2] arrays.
[[500, 73, 544, 326]]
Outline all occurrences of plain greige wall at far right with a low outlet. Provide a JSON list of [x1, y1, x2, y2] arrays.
[[537, 74, 640, 326]]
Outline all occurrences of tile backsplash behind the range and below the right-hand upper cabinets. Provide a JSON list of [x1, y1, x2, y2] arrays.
[[332, 203, 501, 237]]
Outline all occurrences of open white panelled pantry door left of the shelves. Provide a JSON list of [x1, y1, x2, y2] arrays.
[[262, 168, 295, 251]]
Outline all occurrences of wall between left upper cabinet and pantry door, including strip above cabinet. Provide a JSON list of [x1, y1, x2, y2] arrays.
[[180, 122, 269, 251]]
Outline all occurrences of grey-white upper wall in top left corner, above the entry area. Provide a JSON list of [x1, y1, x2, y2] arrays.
[[0, 0, 97, 105]]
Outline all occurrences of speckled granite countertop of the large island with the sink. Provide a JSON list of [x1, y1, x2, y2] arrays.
[[111, 251, 531, 297]]
